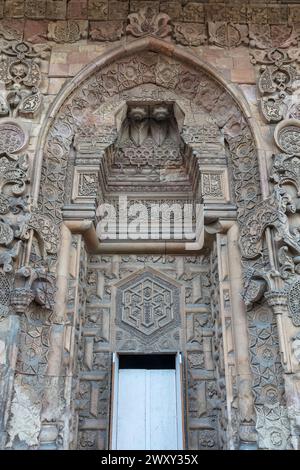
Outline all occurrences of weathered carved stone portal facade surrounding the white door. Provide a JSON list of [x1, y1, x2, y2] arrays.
[[0, 0, 300, 450]]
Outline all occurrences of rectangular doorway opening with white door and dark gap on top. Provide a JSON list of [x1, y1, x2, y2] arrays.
[[112, 354, 183, 450]]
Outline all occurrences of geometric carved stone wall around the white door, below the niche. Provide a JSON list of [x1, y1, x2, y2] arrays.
[[79, 251, 225, 449]]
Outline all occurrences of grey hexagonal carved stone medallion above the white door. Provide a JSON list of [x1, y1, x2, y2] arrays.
[[117, 271, 179, 336]]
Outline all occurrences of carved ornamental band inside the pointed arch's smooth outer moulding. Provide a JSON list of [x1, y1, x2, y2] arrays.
[[39, 53, 258, 235]]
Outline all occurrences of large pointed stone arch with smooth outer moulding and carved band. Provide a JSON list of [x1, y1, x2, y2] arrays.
[[33, 37, 265, 244]]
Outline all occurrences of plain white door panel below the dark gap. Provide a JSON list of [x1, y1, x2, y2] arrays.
[[113, 369, 182, 450]]
